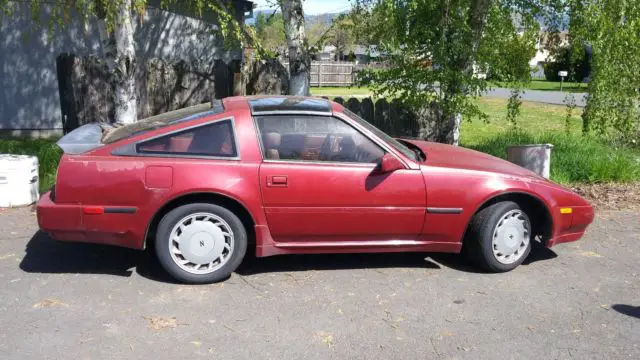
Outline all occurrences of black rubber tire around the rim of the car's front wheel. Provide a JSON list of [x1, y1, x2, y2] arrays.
[[464, 201, 533, 273]]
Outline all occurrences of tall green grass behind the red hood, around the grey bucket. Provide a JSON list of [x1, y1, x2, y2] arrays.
[[469, 131, 640, 184]]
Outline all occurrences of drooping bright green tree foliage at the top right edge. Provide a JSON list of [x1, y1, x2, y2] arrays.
[[566, 0, 640, 140]]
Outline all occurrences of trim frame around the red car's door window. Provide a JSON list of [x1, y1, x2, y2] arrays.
[[252, 111, 392, 168]]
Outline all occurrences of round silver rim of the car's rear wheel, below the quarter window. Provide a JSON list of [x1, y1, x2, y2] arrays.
[[169, 212, 235, 275]]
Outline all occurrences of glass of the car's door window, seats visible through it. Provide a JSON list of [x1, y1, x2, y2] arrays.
[[256, 115, 384, 163]]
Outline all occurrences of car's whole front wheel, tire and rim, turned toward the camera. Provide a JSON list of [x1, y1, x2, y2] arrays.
[[465, 201, 532, 272]]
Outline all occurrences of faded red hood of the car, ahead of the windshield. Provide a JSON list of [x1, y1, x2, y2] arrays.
[[403, 139, 546, 180]]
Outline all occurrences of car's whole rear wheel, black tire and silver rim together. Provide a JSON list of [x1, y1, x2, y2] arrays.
[[155, 203, 247, 284]]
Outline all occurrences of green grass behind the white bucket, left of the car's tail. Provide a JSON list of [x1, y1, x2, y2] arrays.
[[0, 139, 62, 191]]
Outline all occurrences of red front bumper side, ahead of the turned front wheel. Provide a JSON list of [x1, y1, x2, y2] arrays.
[[546, 205, 595, 247]]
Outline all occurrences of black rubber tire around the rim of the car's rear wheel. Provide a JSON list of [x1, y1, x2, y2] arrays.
[[155, 203, 247, 284]]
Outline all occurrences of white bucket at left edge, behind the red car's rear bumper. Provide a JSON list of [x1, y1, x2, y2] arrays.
[[0, 154, 40, 207]]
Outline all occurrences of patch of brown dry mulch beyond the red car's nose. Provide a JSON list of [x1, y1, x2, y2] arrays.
[[571, 183, 640, 210]]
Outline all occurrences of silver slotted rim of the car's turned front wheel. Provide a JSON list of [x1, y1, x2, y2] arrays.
[[491, 210, 531, 264]]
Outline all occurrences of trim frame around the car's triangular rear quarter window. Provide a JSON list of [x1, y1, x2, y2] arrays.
[[111, 116, 241, 161]]
